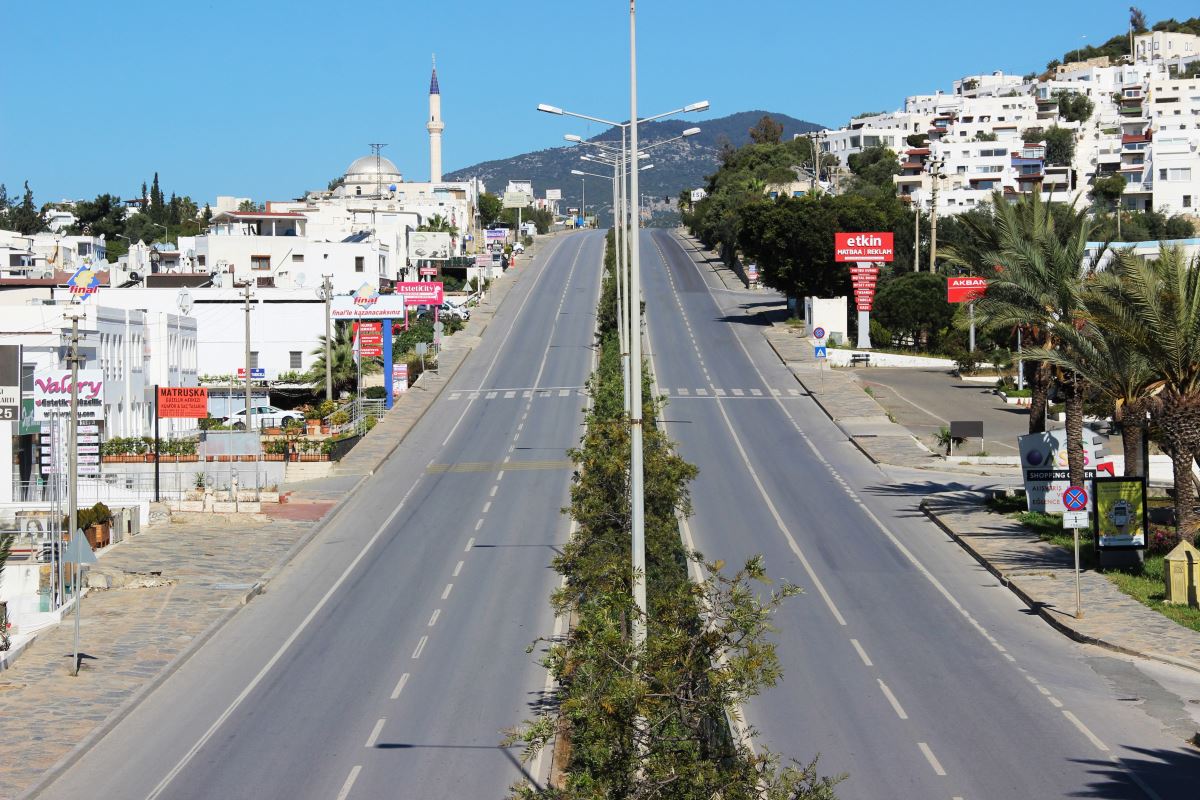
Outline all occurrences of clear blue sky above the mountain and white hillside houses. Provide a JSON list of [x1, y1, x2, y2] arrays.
[[0, 0, 1200, 204]]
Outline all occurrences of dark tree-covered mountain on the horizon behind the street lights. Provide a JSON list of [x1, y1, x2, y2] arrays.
[[446, 112, 822, 217]]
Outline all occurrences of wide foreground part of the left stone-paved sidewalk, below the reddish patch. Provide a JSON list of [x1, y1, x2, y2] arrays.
[[0, 515, 312, 798]]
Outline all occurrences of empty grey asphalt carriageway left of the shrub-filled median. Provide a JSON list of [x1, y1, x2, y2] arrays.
[[42, 233, 604, 800]]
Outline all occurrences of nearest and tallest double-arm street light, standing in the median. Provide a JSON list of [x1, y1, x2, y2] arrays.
[[538, 53, 708, 649]]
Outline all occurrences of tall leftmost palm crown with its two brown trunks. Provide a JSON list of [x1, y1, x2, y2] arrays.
[[964, 192, 1108, 486]]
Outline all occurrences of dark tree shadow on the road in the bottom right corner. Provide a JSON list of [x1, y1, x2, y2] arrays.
[[1069, 745, 1200, 800]]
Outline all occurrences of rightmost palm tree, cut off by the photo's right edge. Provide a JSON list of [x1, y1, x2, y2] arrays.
[[1090, 245, 1200, 534]]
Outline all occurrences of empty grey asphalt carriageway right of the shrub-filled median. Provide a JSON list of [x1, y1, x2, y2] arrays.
[[642, 230, 1200, 800]]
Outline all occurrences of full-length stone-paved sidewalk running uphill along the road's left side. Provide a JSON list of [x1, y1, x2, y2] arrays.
[[0, 232, 568, 800]]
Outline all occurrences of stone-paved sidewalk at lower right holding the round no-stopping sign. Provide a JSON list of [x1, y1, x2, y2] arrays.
[[920, 492, 1200, 672]]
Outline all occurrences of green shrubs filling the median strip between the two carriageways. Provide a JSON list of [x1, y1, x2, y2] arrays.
[[509, 226, 840, 800]]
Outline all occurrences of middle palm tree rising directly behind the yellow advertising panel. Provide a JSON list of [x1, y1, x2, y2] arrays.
[[1030, 319, 1153, 476]]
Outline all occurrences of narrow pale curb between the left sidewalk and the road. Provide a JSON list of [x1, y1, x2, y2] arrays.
[[17, 237, 578, 800]]
